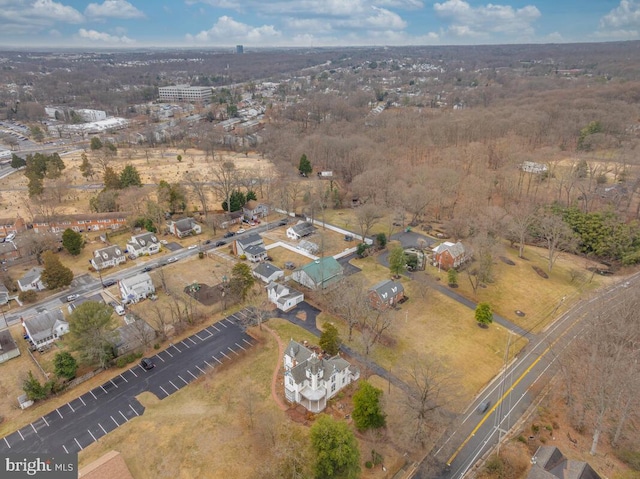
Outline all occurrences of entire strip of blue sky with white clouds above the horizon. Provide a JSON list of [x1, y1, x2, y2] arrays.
[[0, 0, 640, 48]]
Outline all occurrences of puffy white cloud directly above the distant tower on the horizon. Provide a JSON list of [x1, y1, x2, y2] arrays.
[[186, 15, 282, 44]]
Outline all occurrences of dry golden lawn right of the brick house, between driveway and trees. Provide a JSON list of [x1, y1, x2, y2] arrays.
[[426, 246, 611, 332]]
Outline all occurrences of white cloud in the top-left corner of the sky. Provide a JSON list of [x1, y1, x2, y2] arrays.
[[0, 0, 84, 35]]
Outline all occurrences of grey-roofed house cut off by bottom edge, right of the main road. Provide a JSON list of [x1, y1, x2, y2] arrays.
[[527, 446, 601, 479]]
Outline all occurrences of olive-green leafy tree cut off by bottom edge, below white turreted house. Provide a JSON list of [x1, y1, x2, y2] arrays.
[[311, 414, 360, 479]]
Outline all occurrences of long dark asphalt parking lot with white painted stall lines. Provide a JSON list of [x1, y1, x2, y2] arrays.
[[0, 312, 255, 453]]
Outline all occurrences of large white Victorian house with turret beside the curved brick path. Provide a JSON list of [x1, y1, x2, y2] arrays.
[[284, 340, 360, 413]]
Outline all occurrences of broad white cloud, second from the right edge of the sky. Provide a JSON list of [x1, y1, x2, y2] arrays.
[[433, 0, 541, 37]]
